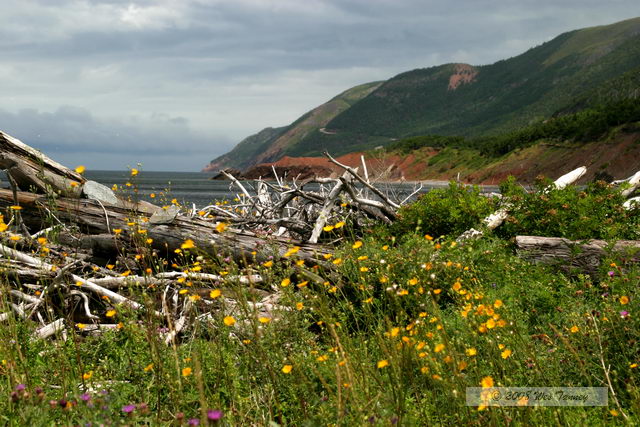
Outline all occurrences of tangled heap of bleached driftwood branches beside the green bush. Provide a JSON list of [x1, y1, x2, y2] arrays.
[[216, 152, 422, 244]]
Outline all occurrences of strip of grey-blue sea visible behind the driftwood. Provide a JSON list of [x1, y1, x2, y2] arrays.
[[85, 170, 480, 207]]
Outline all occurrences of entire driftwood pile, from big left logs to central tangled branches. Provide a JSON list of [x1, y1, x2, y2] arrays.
[[0, 132, 420, 343]]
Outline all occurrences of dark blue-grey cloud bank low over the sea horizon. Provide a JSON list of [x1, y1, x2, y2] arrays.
[[0, 106, 232, 170]]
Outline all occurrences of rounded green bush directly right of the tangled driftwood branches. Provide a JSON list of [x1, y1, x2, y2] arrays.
[[391, 182, 495, 237]]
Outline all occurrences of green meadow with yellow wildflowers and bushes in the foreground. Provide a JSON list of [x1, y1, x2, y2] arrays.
[[0, 176, 640, 426]]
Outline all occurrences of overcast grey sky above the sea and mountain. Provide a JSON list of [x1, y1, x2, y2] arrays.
[[0, 0, 640, 171]]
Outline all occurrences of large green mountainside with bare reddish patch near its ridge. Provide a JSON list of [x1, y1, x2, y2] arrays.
[[204, 18, 640, 171]]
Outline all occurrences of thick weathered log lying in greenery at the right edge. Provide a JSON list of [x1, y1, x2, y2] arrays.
[[516, 236, 640, 275]]
